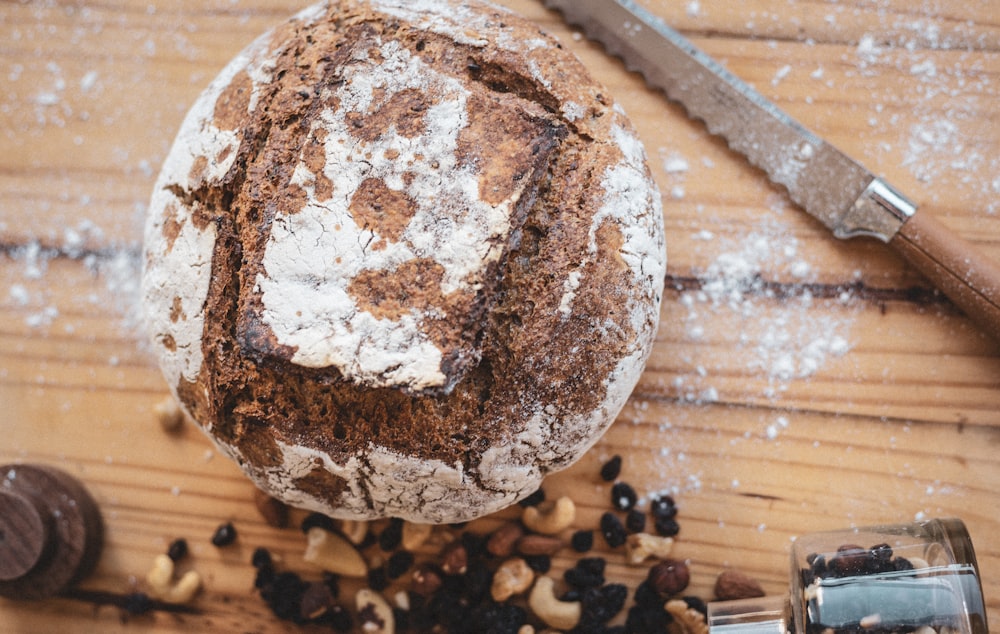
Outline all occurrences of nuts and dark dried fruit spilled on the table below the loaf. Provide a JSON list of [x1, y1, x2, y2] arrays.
[[151, 456, 763, 634]]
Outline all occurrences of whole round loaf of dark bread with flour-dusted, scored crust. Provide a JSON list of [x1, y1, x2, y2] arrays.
[[143, 0, 665, 523]]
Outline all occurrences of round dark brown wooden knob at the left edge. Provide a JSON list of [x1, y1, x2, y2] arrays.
[[0, 465, 104, 599]]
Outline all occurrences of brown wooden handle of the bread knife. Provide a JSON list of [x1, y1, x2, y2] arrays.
[[889, 212, 1000, 341]]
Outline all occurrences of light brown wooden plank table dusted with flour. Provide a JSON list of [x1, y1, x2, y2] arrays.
[[0, 0, 1000, 632]]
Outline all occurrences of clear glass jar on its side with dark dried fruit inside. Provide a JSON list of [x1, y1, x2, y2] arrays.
[[708, 519, 989, 634]]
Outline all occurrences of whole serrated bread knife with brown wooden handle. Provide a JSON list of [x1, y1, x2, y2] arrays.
[[543, 0, 1000, 340]]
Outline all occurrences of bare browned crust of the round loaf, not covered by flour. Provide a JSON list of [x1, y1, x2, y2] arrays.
[[164, 0, 660, 507]]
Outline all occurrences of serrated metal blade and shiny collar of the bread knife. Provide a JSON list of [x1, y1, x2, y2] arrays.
[[543, 0, 916, 242]]
